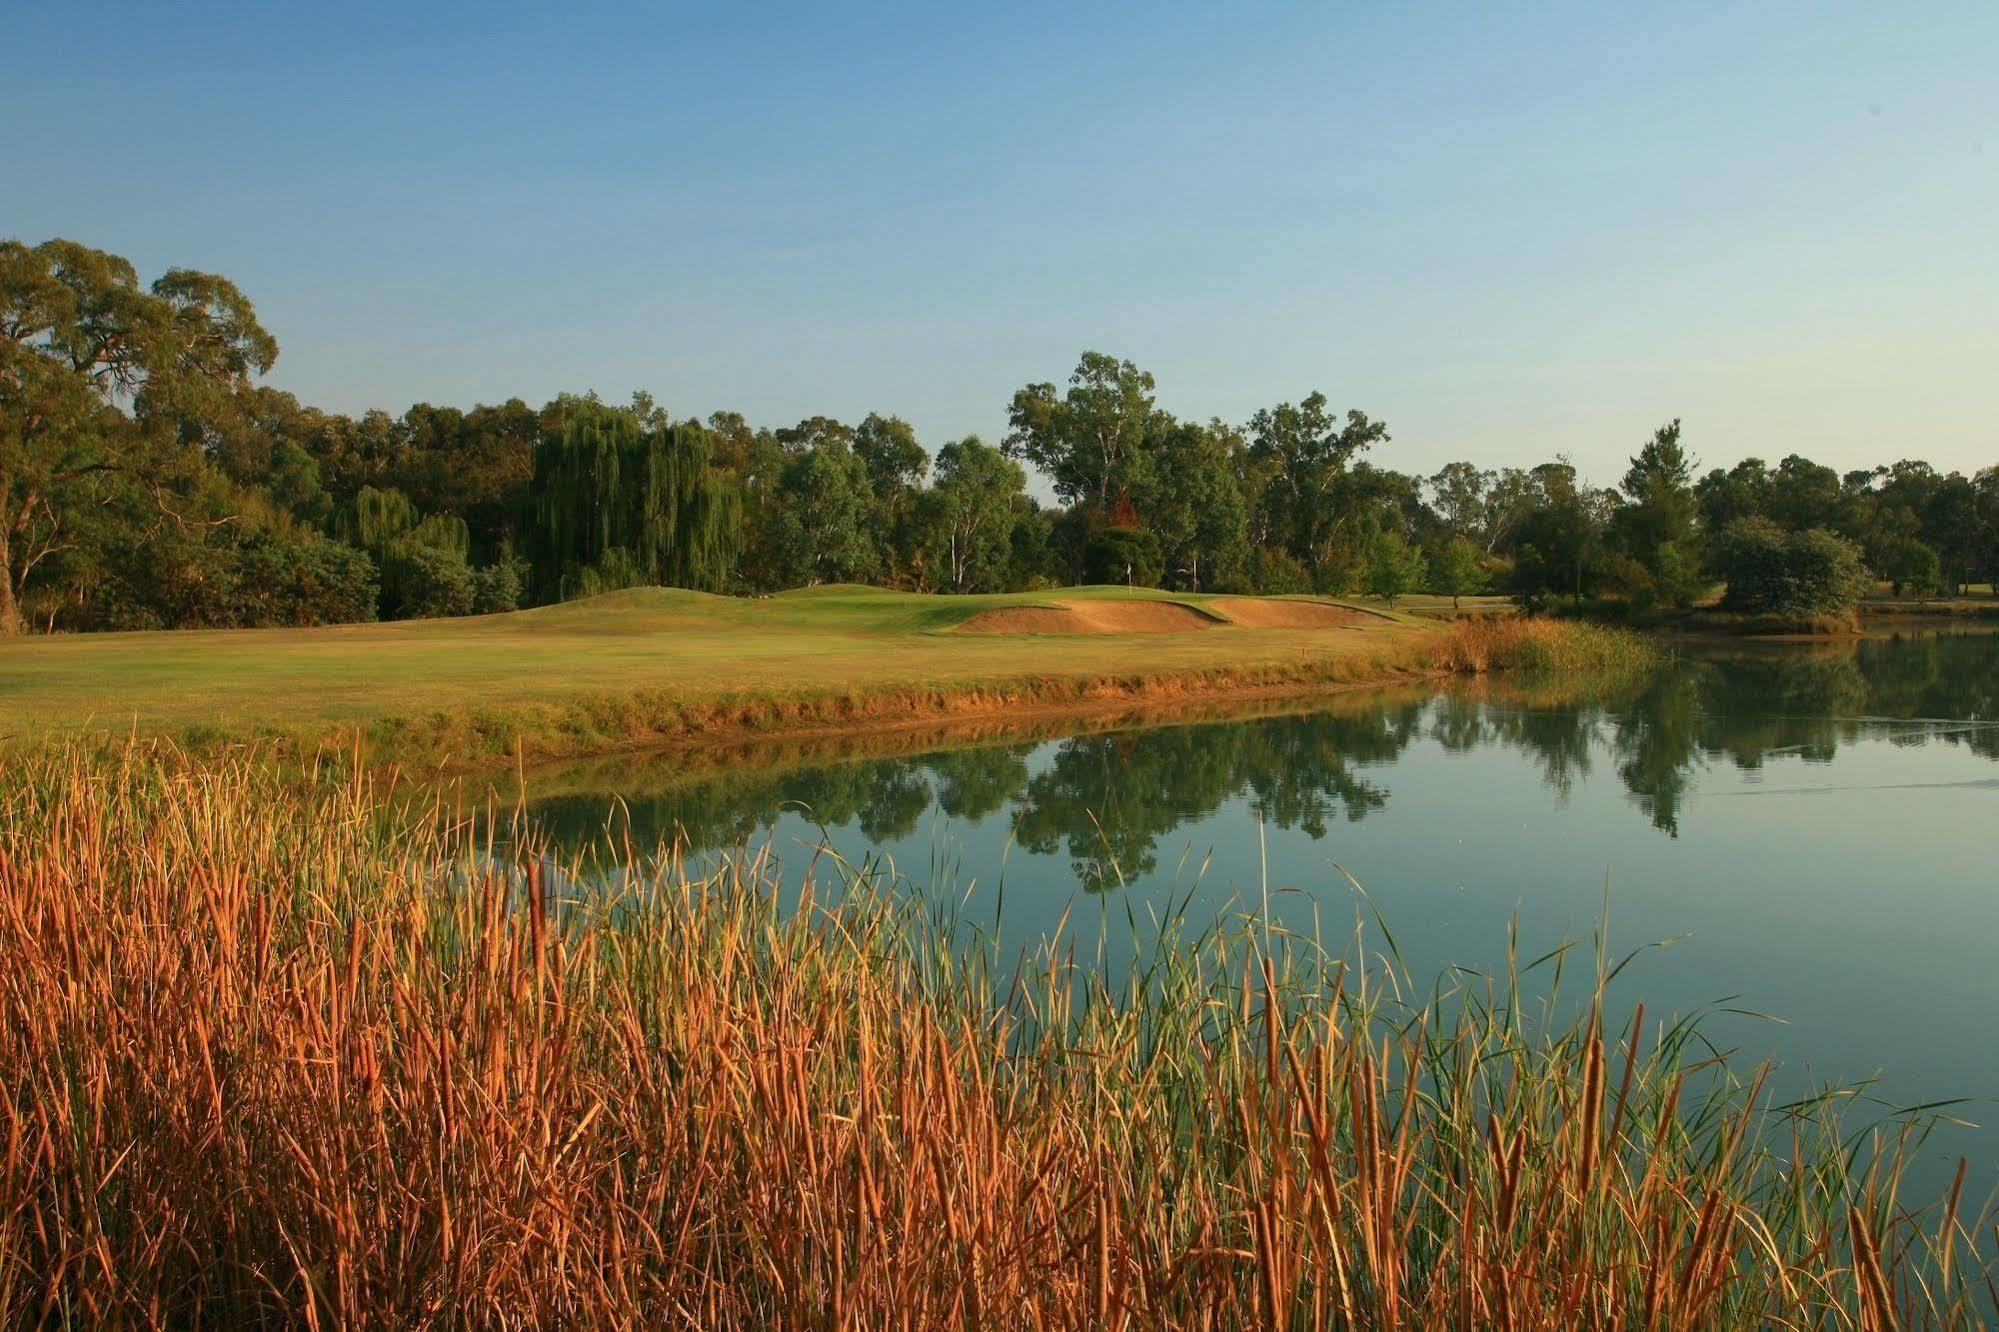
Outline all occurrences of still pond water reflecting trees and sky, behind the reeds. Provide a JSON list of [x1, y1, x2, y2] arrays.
[[507, 634, 1999, 1186]]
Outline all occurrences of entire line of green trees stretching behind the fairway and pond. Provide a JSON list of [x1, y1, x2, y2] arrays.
[[0, 240, 1999, 632]]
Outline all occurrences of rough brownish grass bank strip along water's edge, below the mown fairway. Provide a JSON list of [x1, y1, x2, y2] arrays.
[[4, 616, 1655, 776]]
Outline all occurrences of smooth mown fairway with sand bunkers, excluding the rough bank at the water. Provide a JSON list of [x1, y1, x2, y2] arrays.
[[0, 586, 1437, 740]]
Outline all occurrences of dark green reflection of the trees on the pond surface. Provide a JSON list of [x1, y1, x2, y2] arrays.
[[511, 634, 1999, 888]]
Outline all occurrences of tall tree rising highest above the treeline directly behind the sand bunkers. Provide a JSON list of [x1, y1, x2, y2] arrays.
[[1001, 352, 1153, 522]]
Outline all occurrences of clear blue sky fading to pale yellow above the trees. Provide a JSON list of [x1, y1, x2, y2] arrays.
[[0, 0, 1999, 480]]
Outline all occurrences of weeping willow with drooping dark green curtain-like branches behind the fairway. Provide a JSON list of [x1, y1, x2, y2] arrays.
[[522, 404, 742, 600]]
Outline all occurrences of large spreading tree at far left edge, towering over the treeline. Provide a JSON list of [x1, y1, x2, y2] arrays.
[[0, 240, 278, 634]]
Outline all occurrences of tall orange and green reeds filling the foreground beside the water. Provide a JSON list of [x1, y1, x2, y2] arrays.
[[0, 748, 1987, 1328]]
